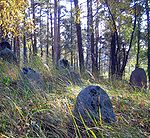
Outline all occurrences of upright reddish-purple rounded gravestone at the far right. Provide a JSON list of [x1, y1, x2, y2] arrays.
[[130, 67, 147, 90]]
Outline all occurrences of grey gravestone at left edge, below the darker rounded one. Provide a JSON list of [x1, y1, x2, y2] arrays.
[[0, 48, 17, 63]]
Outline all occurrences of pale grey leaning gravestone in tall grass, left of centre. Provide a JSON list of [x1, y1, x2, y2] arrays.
[[20, 67, 45, 90]]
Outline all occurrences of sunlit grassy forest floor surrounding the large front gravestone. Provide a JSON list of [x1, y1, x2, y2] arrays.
[[0, 58, 150, 138]]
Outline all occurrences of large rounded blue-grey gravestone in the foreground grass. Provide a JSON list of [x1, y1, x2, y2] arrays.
[[73, 85, 116, 123]]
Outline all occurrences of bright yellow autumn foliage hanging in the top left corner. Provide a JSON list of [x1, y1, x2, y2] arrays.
[[0, 0, 28, 36]]
